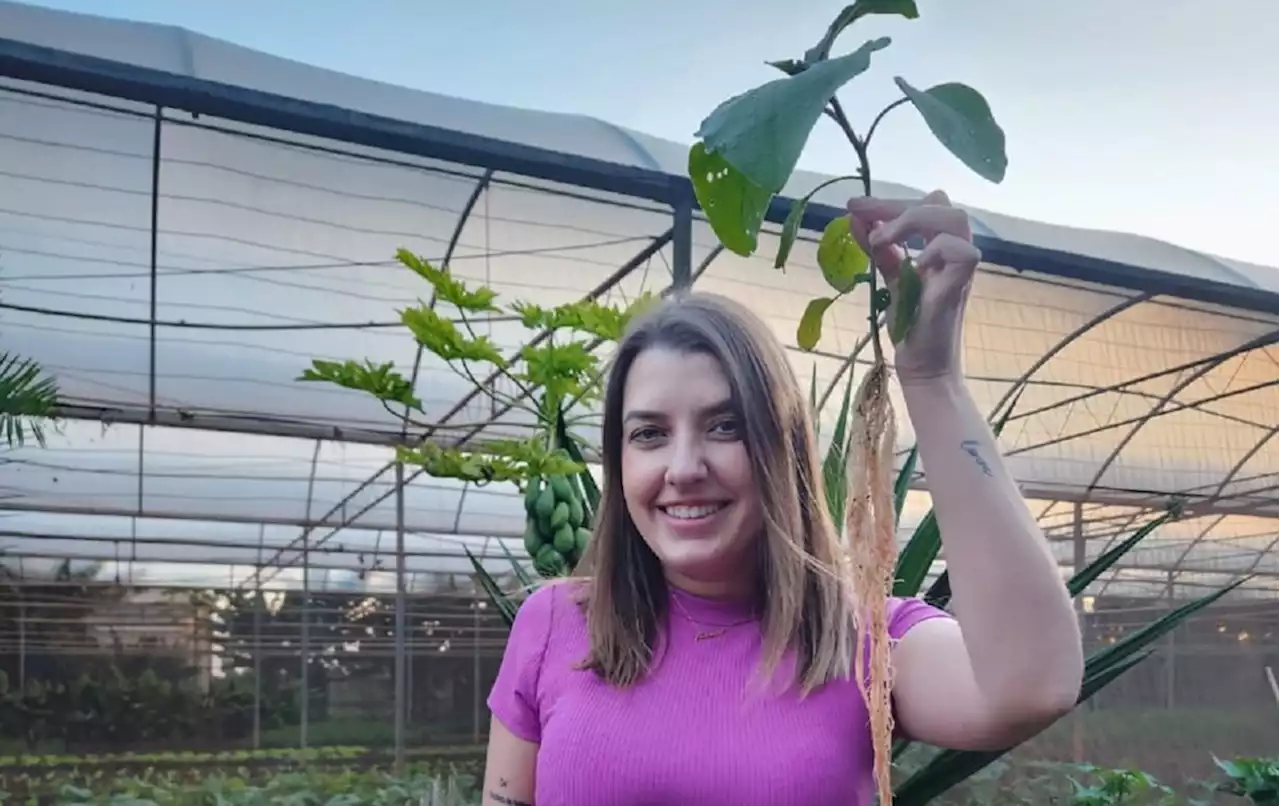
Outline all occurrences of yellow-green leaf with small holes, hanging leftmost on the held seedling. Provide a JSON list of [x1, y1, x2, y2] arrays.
[[689, 143, 773, 257]]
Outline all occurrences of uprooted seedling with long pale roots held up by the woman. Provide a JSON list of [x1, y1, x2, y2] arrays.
[[689, 0, 1007, 803]]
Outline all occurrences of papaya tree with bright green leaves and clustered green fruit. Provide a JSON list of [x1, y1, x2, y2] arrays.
[[298, 249, 653, 615]]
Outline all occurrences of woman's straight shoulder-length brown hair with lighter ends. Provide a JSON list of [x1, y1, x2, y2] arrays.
[[575, 293, 855, 693]]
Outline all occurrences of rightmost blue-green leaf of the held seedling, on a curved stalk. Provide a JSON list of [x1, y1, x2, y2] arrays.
[[893, 77, 1009, 184]]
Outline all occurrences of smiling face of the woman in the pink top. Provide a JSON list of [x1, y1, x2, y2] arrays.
[[622, 348, 763, 596]]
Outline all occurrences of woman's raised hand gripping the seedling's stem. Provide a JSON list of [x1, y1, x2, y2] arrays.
[[849, 191, 982, 384]]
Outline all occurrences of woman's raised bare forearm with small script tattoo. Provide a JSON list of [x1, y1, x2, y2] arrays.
[[902, 377, 1083, 711]]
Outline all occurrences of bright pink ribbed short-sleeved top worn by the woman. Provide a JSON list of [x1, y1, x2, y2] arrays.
[[489, 585, 950, 806]]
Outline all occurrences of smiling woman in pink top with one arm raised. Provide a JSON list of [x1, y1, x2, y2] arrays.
[[484, 192, 1083, 806]]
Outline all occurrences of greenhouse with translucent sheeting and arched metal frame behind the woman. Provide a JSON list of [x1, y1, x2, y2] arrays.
[[0, 0, 1280, 782]]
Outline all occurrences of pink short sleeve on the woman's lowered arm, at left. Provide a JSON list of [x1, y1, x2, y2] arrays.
[[488, 585, 556, 742]]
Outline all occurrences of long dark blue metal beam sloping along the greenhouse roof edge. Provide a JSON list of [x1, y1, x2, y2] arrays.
[[0, 37, 1277, 313]]
